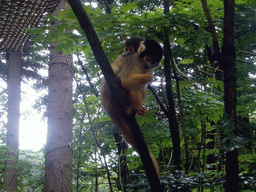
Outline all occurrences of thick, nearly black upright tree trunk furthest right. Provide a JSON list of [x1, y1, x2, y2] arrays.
[[221, 0, 239, 192]]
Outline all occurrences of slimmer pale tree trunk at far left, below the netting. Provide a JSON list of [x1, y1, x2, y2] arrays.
[[4, 52, 21, 191]]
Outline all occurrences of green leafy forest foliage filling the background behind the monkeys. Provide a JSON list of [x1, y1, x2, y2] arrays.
[[0, 0, 256, 191]]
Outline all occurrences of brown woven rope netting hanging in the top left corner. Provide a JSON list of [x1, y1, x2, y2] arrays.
[[0, 0, 59, 53]]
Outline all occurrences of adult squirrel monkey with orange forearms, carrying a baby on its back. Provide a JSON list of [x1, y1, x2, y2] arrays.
[[100, 40, 163, 173]]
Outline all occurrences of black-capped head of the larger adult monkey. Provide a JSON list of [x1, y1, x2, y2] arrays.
[[140, 40, 163, 69]]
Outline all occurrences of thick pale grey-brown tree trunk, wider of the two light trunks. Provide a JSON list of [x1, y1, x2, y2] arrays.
[[44, 1, 73, 192]]
